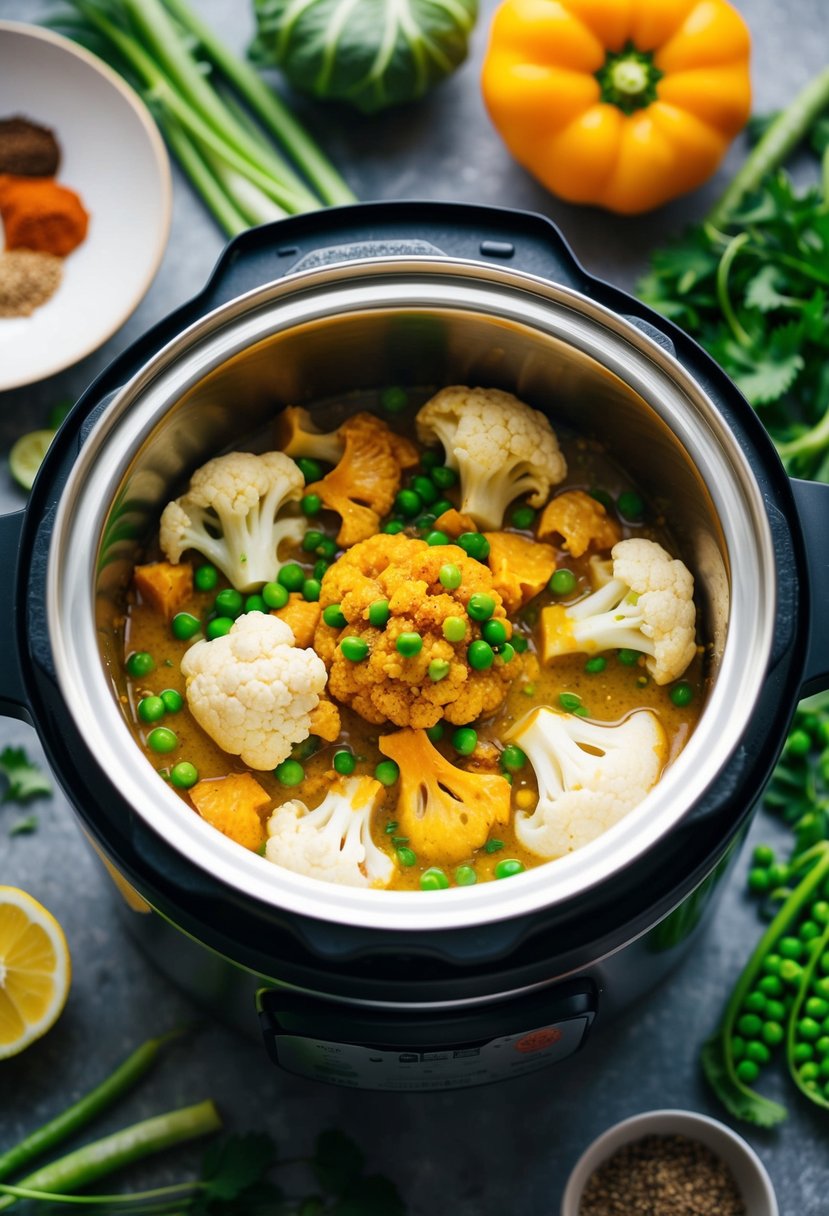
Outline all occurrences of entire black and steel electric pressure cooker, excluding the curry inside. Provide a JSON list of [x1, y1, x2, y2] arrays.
[[0, 203, 829, 1090]]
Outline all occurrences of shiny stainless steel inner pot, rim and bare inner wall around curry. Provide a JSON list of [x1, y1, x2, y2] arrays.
[[47, 257, 776, 930]]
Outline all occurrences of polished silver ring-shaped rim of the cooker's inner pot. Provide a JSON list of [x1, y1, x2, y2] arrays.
[[46, 255, 777, 930]]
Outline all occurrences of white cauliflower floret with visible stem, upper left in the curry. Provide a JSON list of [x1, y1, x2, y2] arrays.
[[159, 452, 305, 591]]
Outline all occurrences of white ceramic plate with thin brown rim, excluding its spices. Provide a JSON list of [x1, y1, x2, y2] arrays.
[[0, 21, 171, 390]]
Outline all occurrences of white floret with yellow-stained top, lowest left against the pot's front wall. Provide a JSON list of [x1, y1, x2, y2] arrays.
[[265, 777, 395, 886]]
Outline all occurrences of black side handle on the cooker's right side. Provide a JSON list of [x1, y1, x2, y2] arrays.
[[791, 478, 829, 697]]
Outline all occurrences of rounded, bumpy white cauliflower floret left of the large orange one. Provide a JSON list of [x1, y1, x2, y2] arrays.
[[181, 612, 327, 770]]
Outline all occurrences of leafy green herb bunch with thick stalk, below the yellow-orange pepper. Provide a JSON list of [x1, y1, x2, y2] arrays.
[[638, 71, 829, 482]]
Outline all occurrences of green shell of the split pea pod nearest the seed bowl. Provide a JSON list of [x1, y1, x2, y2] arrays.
[[700, 841, 829, 1127]]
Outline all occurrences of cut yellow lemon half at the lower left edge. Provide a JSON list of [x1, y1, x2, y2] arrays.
[[0, 886, 72, 1059]]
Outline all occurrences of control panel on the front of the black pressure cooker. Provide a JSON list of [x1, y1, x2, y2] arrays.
[[258, 984, 596, 1092]]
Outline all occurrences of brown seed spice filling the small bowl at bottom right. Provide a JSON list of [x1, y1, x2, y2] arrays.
[[579, 1136, 748, 1216]]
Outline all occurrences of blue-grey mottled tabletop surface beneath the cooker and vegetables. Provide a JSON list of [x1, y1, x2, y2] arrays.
[[0, 0, 829, 1216]]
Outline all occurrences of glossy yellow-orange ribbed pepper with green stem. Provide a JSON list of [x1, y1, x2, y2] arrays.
[[481, 0, 751, 214]]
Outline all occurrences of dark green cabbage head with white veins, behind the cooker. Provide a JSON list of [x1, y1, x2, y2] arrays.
[[250, 0, 478, 114]]
